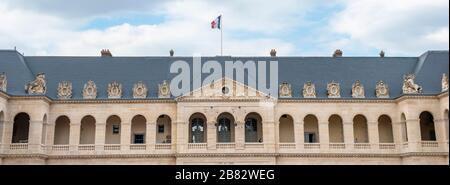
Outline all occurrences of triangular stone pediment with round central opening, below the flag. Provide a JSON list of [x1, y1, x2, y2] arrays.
[[176, 77, 273, 100]]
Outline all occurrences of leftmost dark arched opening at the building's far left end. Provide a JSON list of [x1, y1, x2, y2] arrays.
[[11, 113, 30, 143]]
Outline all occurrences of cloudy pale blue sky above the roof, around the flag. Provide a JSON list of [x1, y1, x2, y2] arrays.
[[0, 0, 449, 56]]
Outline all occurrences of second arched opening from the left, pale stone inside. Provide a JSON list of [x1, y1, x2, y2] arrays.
[[53, 116, 70, 145]]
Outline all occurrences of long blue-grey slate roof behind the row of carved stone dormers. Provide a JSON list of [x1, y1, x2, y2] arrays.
[[0, 50, 449, 99]]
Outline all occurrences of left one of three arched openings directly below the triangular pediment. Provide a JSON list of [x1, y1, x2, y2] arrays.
[[189, 113, 208, 143]]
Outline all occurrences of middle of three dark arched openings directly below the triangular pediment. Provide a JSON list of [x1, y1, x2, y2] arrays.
[[217, 113, 234, 143]]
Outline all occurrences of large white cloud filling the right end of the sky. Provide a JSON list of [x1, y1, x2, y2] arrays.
[[330, 0, 449, 56]]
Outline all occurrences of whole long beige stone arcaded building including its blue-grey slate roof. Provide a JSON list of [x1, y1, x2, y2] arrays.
[[0, 50, 449, 165]]
